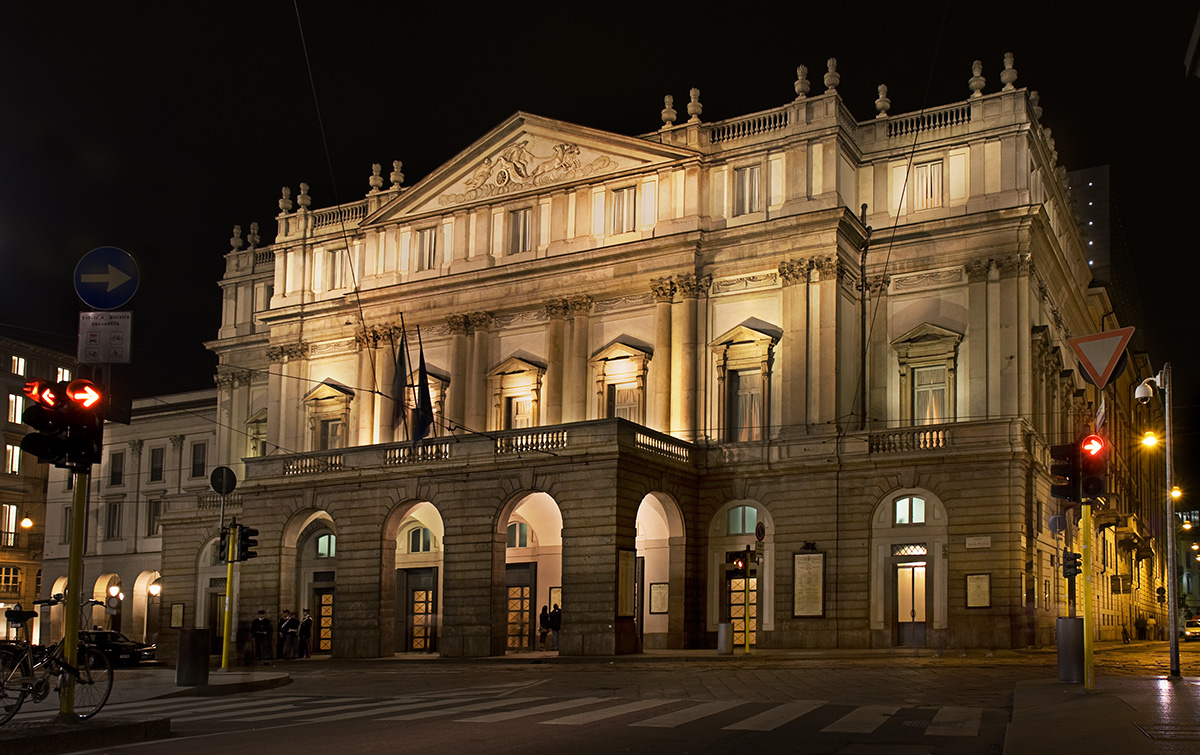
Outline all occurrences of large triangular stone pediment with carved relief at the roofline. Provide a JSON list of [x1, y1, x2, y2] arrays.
[[360, 113, 696, 227]]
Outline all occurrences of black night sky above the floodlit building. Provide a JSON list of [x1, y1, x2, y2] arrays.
[[0, 0, 1200, 480]]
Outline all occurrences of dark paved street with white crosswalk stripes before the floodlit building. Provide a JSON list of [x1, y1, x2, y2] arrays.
[[7, 643, 1200, 755]]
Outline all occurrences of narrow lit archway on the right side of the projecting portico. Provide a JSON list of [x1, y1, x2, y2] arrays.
[[634, 492, 685, 649]]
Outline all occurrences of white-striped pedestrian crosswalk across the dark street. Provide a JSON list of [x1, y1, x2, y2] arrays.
[[18, 689, 985, 737]]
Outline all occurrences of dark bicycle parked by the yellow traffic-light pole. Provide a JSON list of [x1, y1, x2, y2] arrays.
[[0, 595, 113, 726]]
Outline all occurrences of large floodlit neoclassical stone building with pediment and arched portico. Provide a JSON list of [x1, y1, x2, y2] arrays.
[[152, 59, 1165, 657]]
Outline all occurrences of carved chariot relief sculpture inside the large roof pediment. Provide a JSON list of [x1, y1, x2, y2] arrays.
[[438, 139, 617, 205]]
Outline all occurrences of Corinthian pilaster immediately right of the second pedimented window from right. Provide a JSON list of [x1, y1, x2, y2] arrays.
[[779, 259, 812, 433]]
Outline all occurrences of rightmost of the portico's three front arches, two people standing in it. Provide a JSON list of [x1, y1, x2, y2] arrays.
[[499, 492, 565, 652]]
